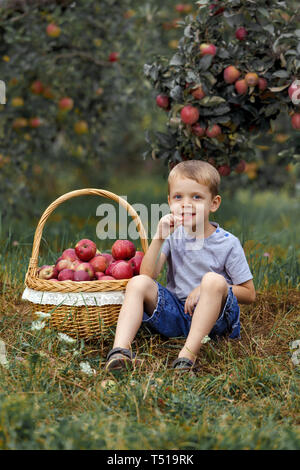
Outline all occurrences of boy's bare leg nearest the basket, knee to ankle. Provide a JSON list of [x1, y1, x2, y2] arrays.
[[113, 274, 158, 349]]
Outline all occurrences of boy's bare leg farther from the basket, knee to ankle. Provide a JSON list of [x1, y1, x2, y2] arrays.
[[178, 272, 228, 362]]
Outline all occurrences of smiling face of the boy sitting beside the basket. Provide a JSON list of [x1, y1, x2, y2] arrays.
[[168, 177, 221, 231]]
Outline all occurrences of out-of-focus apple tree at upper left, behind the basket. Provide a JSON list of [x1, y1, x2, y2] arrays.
[[0, 0, 191, 219]]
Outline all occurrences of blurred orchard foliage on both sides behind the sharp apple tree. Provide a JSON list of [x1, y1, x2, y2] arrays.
[[0, 0, 299, 237]]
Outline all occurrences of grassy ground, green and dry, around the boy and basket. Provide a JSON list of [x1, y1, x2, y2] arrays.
[[0, 179, 300, 450]]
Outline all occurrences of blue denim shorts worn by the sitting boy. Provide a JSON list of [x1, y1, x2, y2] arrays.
[[143, 281, 240, 339]]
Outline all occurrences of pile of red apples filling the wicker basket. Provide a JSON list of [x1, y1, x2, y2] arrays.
[[38, 238, 144, 281]]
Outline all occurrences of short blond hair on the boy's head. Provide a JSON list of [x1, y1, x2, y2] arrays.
[[168, 160, 221, 198]]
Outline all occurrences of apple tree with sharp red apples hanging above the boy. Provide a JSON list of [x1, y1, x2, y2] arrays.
[[144, 0, 300, 191]]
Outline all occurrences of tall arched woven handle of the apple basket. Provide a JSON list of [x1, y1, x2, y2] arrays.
[[27, 188, 148, 276]]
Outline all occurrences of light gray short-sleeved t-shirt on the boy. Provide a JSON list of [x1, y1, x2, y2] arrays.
[[161, 222, 253, 300]]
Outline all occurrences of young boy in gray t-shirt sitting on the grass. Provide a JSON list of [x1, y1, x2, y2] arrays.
[[106, 160, 255, 371]]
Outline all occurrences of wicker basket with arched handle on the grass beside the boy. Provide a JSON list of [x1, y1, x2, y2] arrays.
[[25, 188, 148, 339]]
